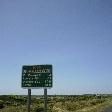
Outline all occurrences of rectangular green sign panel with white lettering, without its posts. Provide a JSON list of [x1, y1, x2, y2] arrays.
[[21, 65, 53, 88]]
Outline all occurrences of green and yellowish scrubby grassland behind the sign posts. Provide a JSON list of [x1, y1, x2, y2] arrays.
[[0, 94, 112, 112]]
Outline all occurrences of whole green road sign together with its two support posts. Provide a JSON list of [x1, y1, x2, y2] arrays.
[[21, 64, 53, 112]]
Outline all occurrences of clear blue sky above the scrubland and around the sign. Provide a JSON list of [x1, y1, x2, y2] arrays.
[[0, 0, 112, 94]]
